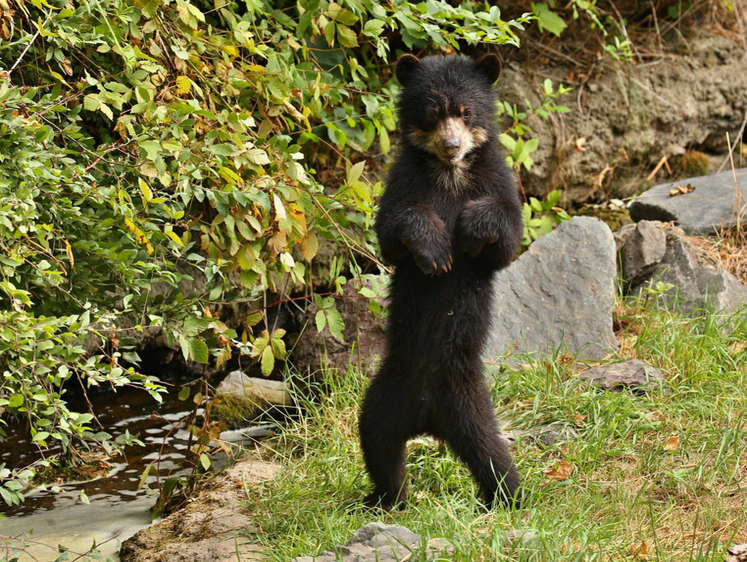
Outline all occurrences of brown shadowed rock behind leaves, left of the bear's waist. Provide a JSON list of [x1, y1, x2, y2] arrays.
[[289, 279, 385, 382]]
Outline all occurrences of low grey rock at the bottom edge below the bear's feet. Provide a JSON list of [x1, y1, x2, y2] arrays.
[[292, 522, 454, 562]]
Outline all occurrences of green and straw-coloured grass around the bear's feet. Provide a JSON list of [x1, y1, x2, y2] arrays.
[[240, 306, 747, 562]]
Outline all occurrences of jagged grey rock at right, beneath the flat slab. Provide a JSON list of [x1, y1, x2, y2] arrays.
[[616, 220, 747, 314]]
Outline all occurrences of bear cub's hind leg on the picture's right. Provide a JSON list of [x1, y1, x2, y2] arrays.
[[443, 375, 521, 508]]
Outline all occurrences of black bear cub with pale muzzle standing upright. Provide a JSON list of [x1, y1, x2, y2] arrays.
[[359, 55, 522, 509]]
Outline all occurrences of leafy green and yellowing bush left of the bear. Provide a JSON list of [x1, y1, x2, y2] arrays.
[[0, 0, 526, 503]]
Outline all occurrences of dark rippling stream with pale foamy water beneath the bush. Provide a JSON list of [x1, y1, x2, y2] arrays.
[[0, 385, 196, 562]]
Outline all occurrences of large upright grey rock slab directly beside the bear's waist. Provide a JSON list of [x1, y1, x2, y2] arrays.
[[483, 212, 618, 361]]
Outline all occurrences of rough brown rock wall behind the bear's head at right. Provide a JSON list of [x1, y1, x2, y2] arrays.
[[498, 33, 747, 204]]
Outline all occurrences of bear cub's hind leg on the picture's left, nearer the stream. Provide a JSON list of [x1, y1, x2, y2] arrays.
[[358, 379, 411, 509]]
